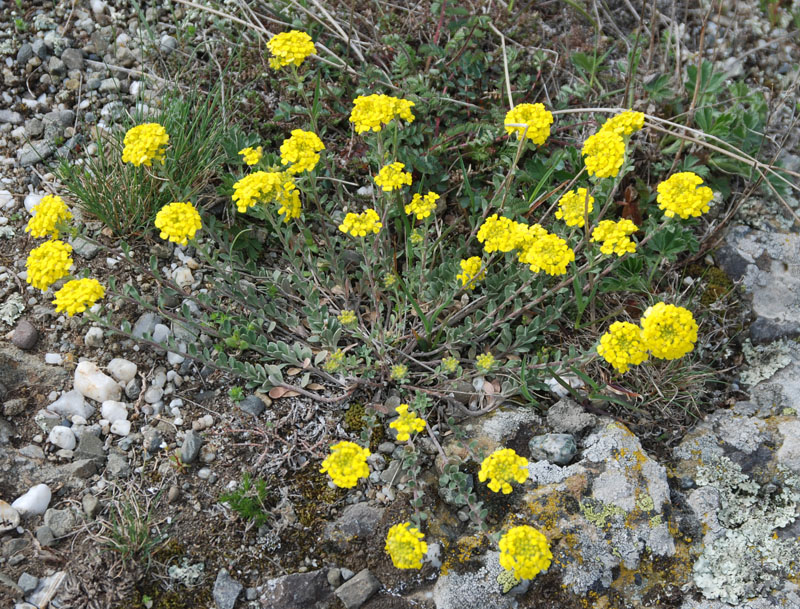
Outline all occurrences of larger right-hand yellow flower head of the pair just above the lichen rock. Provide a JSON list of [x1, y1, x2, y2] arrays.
[[639, 302, 697, 359]]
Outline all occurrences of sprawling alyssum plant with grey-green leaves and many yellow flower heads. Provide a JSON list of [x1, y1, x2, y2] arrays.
[[34, 31, 764, 578]]
